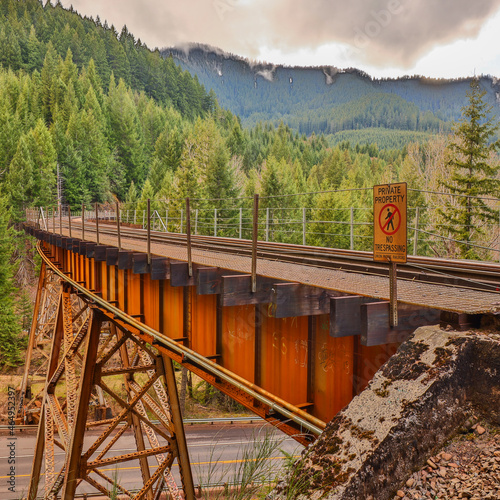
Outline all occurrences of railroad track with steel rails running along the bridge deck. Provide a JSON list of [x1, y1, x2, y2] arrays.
[[45, 221, 500, 294]]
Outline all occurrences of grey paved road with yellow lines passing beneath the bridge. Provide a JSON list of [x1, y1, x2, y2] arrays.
[[0, 424, 302, 500]]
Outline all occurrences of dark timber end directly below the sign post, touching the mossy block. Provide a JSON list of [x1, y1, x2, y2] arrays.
[[361, 302, 441, 346]]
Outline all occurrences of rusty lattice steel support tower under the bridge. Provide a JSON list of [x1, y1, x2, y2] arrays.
[[27, 258, 195, 500]]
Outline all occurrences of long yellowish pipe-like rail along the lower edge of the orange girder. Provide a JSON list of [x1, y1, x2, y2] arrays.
[[37, 242, 326, 435]]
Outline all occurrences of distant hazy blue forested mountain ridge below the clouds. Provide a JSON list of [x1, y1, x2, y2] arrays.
[[162, 45, 500, 145]]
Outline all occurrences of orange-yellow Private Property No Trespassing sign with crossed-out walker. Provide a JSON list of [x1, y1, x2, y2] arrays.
[[373, 182, 408, 262]]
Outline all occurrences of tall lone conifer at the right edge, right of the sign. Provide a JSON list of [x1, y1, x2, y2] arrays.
[[439, 78, 500, 259]]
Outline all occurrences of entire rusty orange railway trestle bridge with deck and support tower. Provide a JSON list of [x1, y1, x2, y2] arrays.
[[18, 208, 500, 500]]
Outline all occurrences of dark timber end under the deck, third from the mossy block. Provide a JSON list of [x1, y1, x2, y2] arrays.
[[272, 283, 341, 318]]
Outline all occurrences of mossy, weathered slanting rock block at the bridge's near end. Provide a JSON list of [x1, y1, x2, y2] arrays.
[[268, 327, 500, 500]]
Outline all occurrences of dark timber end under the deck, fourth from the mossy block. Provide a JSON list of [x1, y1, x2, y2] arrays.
[[221, 274, 279, 307]]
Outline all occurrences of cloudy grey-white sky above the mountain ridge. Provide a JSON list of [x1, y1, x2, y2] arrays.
[[57, 0, 500, 78]]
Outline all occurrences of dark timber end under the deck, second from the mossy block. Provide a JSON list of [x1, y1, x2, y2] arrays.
[[330, 295, 377, 337]]
